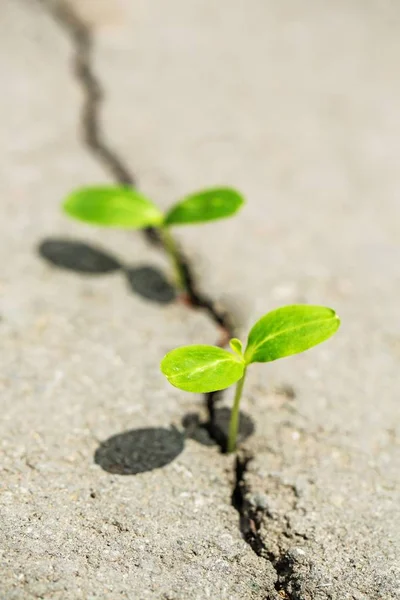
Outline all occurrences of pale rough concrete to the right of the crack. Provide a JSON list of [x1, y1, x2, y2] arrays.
[[87, 0, 400, 600]]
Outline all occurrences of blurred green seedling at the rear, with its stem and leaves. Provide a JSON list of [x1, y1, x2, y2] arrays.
[[63, 186, 244, 290]]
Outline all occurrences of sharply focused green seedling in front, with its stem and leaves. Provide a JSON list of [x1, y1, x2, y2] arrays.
[[161, 305, 340, 452]]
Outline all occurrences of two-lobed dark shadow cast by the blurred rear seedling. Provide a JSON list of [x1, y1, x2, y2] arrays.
[[38, 238, 176, 304]]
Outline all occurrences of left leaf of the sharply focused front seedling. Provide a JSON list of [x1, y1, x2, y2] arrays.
[[161, 345, 244, 393]]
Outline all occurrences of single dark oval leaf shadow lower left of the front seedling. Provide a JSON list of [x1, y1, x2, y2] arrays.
[[94, 427, 185, 475]]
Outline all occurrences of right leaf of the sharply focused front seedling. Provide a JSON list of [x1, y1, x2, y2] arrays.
[[245, 305, 340, 364]]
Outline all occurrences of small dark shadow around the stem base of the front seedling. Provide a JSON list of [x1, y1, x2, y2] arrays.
[[182, 407, 255, 452]]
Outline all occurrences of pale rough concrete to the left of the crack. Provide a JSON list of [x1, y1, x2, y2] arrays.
[[0, 0, 274, 600]]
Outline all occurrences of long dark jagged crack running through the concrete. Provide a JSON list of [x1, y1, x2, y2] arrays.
[[39, 0, 290, 600]]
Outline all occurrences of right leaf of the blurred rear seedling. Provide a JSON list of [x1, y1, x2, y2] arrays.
[[165, 188, 244, 225]]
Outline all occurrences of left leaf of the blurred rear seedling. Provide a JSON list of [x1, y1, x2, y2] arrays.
[[63, 186, 163, 229]]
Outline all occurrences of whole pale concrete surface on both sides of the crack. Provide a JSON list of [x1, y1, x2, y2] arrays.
[[0, 0, 400, 600]]
